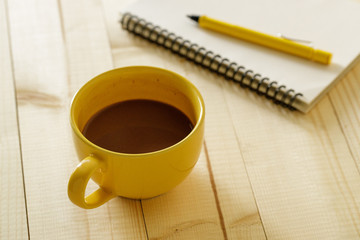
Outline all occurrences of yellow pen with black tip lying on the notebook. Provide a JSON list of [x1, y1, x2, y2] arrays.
[[188, 15, 332, 64]]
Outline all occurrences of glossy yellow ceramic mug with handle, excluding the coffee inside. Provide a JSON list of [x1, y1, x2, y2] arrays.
[[68, 66, 205, 209]]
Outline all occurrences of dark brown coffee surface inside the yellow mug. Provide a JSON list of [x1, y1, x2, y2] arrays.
[[83, 99, 193, 153]]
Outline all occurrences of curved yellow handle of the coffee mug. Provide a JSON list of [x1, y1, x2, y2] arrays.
[[68, 156, 115, 209]]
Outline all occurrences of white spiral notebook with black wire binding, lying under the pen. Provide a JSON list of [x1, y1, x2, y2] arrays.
[[121, 0, 360, 113]]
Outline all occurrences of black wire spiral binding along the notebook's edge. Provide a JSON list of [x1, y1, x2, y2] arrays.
[[120, 13, 302, 110]]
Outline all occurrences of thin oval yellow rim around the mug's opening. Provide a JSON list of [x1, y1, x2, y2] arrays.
[[70, 65, 205, 157]]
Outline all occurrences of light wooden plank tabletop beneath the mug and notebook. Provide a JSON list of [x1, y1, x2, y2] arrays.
[[0, 0, 360, 240]]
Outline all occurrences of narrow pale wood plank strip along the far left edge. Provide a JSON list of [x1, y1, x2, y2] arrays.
[[0, 0, 28, 239]]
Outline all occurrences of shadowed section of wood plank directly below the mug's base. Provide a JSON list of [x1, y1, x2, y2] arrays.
[[142, 151, 226, 239]]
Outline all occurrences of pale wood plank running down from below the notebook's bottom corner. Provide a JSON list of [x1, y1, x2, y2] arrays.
[[222, 82, 360, 239]]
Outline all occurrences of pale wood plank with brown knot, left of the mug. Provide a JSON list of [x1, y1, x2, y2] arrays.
[[9, 1, 89, 236]]
